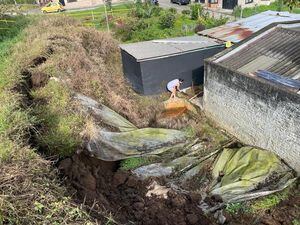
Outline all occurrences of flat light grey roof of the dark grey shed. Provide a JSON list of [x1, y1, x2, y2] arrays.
[[120, 35, 220, 60]]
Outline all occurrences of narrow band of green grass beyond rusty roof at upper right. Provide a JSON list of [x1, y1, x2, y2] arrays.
[[233, 1, 300, 18]]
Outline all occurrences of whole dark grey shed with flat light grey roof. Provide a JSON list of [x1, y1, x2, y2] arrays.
[[120, 35, 224, 95]]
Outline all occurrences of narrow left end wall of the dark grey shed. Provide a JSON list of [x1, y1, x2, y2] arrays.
[[121, 50, 144, 93]]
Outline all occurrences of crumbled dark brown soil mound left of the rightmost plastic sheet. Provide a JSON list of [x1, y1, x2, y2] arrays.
[[59, 153, 214, 225]]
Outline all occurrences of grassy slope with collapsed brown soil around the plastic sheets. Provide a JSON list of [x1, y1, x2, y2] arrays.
[[0, 14, 299, 224]]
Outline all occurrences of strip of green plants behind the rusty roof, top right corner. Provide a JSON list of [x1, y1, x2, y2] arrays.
[[233, 0, 300, 18]]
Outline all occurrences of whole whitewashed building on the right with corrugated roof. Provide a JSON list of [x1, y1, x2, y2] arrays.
[[203, 21, 300, 174]]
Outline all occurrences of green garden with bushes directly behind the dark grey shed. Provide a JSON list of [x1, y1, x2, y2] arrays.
[[68, 1, 227, 42]]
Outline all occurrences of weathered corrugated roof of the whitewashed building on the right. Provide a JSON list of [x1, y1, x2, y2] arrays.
[[219, 23, 300, 80]]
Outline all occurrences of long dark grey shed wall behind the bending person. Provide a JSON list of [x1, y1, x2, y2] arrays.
[[140, 45, 224, 95]]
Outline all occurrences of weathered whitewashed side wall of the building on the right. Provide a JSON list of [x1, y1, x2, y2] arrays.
[[203, 62, 300, 174]]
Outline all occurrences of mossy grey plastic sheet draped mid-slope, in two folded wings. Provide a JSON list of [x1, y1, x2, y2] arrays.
[[75, 94, 187, 161]]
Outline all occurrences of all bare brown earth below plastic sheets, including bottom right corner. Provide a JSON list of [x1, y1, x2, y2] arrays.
[[59, 152, 300, 225]]
